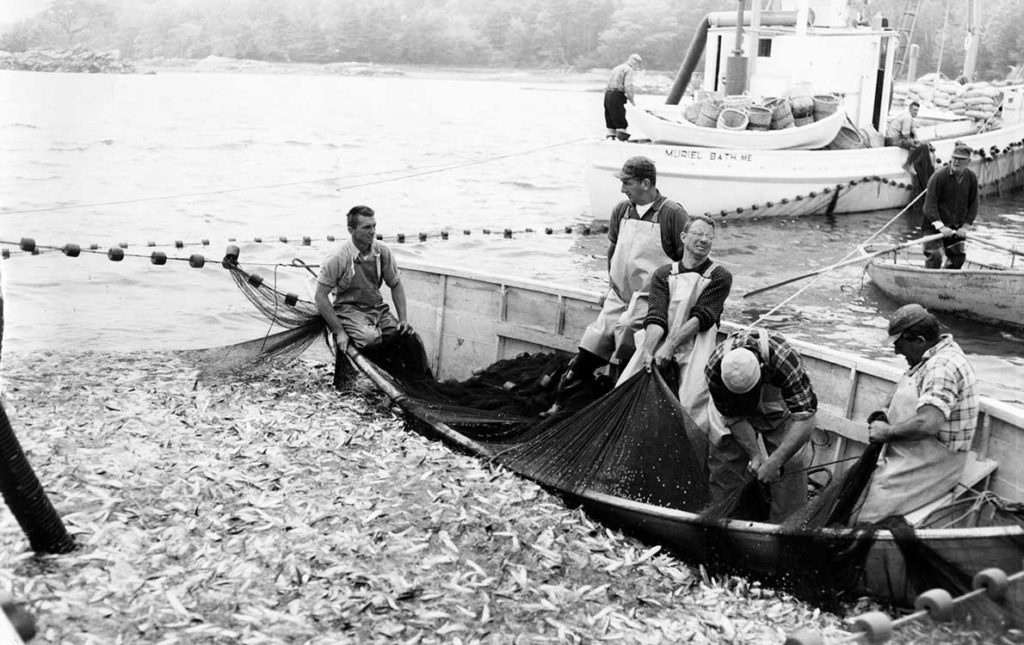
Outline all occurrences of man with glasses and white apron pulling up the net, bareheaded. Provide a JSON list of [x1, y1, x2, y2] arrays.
[[618, 215, 732, 450]]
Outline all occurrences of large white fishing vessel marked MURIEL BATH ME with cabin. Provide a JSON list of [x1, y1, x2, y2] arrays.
[[585, 0, 1024, 219]]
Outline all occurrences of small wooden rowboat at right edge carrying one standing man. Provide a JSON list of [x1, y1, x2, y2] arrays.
[[867, 258, 1024, 328]]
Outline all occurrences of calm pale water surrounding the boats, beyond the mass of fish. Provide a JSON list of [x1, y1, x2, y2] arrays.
[[0, 72, 1024, 400]]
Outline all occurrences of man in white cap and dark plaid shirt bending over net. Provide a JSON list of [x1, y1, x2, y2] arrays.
[[705, 329, 818, 523]]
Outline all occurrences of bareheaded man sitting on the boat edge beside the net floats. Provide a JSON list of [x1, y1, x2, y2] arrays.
[[313, 206, 428, 374]]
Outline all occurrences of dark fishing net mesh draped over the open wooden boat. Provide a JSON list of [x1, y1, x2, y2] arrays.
[[209, 256, 1024, 605]]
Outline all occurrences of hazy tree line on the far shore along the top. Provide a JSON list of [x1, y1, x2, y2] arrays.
[[0, 0, 1024, 79]]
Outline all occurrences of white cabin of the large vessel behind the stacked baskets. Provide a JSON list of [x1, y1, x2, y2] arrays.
[[695, 0, 897, 132]]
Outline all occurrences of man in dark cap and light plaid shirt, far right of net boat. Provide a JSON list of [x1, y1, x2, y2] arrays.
[[857, 304, 978, 522]]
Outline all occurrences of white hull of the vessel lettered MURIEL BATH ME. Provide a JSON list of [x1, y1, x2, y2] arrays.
[[585, 124, 1024, 220]]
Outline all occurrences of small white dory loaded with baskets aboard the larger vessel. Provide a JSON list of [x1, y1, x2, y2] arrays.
[[626, 104, 846, 151]]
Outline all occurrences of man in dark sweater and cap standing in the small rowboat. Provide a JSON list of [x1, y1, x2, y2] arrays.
[[922, 141, 978, 269]]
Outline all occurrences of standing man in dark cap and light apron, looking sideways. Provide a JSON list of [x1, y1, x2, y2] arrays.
[[549, 157, 687, 412]]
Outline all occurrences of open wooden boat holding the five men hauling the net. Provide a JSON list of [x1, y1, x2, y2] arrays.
[[349, 256, 1024, 603]]
